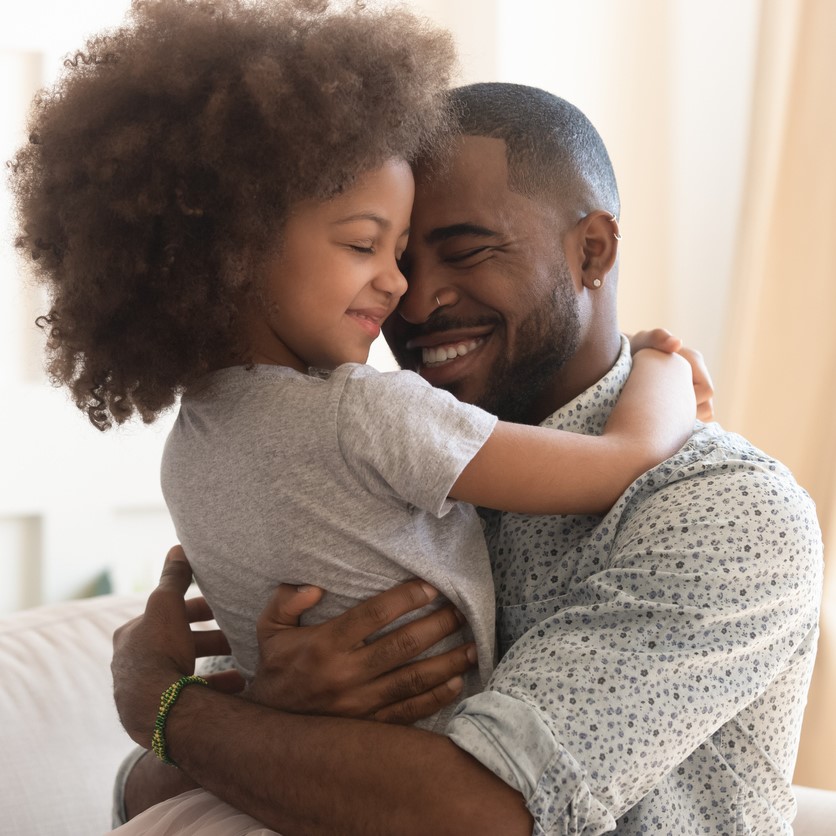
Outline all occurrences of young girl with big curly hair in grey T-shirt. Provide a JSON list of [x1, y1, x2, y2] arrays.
[[13, 0, 694, 832]]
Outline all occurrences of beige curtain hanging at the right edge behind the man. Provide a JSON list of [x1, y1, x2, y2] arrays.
[[718, 0, 836, 789]]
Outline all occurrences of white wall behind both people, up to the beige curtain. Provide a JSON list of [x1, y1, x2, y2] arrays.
[[0, 0, 759, 612]]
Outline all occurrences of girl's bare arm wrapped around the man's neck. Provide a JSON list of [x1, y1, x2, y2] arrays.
[[450, 349, 696, 514]]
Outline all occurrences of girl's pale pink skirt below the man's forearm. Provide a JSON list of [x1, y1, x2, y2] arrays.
[[105, 790, 279, 836]]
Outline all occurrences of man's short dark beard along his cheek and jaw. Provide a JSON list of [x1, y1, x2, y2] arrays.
[[470, 268, 581, 424]]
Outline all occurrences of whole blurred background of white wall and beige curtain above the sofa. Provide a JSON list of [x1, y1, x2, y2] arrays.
[[0, 0, 836, 789]]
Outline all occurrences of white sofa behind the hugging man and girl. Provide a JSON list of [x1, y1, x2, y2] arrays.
[[0, 596, 836, 836]]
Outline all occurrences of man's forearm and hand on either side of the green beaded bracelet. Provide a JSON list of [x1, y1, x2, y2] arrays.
[[113, 551, 532, 836]]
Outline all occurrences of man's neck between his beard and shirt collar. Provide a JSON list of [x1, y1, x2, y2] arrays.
[[526, 328, 621, 425]]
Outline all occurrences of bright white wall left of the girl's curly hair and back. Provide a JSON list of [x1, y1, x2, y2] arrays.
[[0, 0, 180, 613]]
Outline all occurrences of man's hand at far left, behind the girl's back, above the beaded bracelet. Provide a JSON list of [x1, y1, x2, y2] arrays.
[[110, 546, 235, 747]]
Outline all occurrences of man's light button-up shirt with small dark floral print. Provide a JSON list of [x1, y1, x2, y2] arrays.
[[448, 340, 822, 836]]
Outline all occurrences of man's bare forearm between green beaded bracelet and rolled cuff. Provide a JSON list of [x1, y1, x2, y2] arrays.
[[167, 687, 532, 836]]
